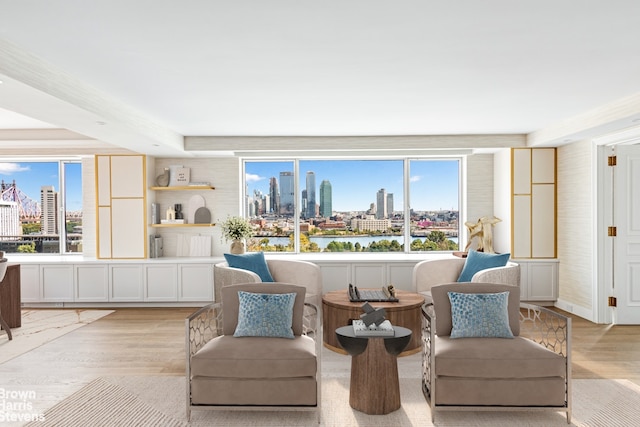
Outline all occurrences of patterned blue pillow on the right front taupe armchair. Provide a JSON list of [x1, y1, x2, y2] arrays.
[[447, 292, 513, 338]]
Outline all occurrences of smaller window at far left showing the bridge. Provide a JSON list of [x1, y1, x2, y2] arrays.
[[0, 160, 82, 253]]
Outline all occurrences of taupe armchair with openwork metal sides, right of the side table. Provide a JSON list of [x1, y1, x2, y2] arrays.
[[422, 283, 571, 423]]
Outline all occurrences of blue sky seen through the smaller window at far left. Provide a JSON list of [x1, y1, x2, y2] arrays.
[[0, 162, 82, 211]]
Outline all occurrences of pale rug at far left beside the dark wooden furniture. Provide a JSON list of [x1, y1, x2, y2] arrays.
[[0, 309, 113, 364]]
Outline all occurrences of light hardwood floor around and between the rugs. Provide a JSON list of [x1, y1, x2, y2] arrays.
[[0, 308, 640, 414]]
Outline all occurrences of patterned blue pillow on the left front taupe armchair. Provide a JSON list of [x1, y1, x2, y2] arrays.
[[233, 291, 296, 339]]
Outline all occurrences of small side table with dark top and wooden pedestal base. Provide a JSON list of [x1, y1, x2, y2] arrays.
[[335, 325, 411, 415]]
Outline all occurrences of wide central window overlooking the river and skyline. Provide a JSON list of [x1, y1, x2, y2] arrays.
[[243, 158, 461, 252]]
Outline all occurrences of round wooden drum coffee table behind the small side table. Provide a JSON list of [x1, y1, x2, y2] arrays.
[[322, 289, 424, 356]]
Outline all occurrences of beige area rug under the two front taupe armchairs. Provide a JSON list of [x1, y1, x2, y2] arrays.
[[22, 376, 640, 427]]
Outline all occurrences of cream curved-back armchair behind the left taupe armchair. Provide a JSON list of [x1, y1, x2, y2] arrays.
[[213, 259, 322, 307]]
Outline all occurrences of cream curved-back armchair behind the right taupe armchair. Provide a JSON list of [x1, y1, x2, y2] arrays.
[[412, 255, 520, 302]]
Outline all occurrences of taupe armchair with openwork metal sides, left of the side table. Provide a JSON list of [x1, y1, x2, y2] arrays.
[[186, 283, 321, 422]]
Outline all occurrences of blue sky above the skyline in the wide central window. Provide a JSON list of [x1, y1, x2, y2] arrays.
[[245, 160, 459, 211]]
